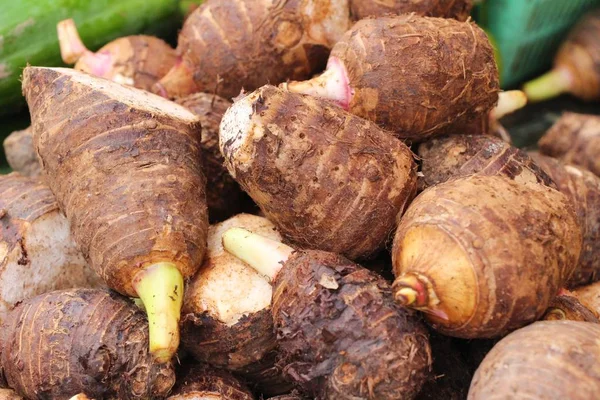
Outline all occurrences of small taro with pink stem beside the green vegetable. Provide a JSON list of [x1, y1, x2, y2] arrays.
[[56, 19, 177, 90]]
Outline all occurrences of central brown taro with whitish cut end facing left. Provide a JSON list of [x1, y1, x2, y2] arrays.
[[220, 86, 416, 259]]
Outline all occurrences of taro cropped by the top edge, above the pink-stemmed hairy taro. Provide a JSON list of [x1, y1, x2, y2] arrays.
[[350, 0, 473, 21]]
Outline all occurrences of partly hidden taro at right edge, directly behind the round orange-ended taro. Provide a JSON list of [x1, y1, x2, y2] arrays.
[[530, 153, 600, 287]]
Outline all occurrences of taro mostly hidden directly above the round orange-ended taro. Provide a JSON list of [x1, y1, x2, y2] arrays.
[[418, 135, 556, 190]]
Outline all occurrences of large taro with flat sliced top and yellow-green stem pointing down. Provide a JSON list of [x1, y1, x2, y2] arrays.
[[23, 67, 208, 362]]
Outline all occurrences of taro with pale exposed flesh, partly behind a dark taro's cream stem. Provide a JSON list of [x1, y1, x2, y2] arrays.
[[181, 214, 290, 394]]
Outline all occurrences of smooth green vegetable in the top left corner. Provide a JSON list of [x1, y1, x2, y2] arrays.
[[0, 0, 181, 114]]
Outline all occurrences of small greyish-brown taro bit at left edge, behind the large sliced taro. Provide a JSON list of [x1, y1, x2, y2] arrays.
[[4, 127, 42, 177]]
